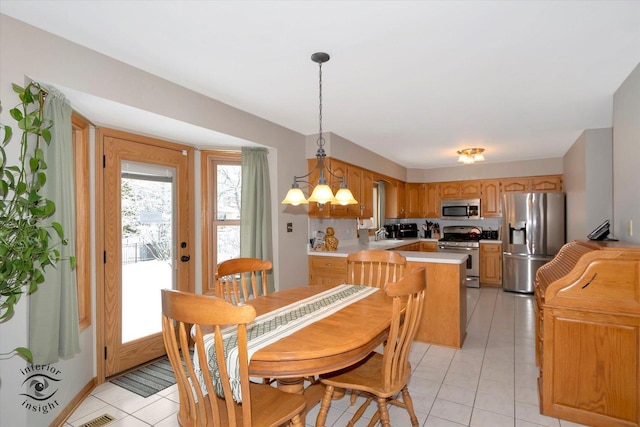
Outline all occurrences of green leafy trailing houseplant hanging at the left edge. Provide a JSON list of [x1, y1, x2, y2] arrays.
[[0, 83, 75, 360]]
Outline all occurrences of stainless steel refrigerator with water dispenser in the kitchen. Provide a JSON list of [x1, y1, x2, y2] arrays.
[[502, 193, 565, 293]]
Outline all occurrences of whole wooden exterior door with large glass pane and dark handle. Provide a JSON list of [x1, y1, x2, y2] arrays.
[[100, 130, 192, 377]]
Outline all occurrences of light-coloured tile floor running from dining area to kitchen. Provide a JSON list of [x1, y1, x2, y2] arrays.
[[65, 288, 592, 427]]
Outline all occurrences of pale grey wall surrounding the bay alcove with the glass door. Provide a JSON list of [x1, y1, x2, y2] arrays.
[[0, 14, 308, 427]]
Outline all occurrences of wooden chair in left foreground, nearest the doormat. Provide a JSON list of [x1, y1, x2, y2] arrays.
[[162, 289, 306, 427]]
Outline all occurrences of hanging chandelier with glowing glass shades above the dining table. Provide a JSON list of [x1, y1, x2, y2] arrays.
[[282, 52, 358, 206]]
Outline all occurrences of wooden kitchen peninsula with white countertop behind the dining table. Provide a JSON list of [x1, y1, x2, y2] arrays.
[[308, 239, 467, 348]]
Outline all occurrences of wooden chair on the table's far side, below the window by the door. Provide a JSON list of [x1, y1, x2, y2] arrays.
[[215, 258, 273, 305]]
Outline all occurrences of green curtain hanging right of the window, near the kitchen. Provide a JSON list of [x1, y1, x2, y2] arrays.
[[240, 147, 274, 292]]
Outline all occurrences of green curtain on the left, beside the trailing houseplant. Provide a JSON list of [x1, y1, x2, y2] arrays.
[[29, 88, 79, 365]]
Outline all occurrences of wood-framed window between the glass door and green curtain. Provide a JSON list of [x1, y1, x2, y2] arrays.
[[201, 151, 242, 293]]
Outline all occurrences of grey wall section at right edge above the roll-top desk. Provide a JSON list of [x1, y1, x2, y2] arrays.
[[613, 64, 640, 243]]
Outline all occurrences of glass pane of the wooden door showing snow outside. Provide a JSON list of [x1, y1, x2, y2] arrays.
[[120, 161, 175, 343]]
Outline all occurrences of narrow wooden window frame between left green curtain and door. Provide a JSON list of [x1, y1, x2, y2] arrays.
[[71, 113, 91, 331]]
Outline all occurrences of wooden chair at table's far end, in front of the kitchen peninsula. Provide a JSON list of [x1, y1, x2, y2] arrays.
[[347, 249, 407, 288]]
